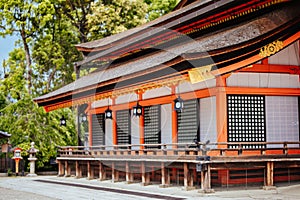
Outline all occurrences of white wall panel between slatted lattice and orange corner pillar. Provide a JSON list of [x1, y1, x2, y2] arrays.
[[200, 97, 217, 148]]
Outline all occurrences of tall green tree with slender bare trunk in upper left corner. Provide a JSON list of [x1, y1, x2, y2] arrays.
[[0, 0, 53, 93]]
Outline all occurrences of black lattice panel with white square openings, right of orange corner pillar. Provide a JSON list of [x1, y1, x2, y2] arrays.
[[227, 95, 266, 148]]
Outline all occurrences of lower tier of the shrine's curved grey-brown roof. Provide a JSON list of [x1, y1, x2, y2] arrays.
[[35, 0, 300, 110]]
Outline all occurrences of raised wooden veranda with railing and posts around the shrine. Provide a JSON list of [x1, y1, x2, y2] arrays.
[[57, 142, 300, 192]]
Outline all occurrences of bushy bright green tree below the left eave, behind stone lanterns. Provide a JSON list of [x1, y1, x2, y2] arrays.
[[0, 48, 77, 167]]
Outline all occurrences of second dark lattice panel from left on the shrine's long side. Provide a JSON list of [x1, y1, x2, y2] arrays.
[[117, 110, 131, 144]]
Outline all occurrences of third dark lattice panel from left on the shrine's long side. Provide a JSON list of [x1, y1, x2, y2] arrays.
[[144, 105, 161, 144]]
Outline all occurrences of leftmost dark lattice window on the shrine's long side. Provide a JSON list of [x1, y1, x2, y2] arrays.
[[92, 113, 105, 146]]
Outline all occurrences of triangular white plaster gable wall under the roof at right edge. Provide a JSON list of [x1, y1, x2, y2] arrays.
[[268, 41, 300, 66]]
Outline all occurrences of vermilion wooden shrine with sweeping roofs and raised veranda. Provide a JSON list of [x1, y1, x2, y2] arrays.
[[35, 0, 300, 192]]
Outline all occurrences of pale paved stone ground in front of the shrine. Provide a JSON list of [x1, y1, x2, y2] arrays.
[[0, 176, 300, 200]]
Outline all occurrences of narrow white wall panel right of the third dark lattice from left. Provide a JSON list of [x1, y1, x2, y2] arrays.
[[161, 104, 172, 148]]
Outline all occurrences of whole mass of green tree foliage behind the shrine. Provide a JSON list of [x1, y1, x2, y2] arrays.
[[0, 0, 177, 170]]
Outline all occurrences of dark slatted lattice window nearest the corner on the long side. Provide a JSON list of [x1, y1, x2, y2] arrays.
[[177, 99, 200, 143]]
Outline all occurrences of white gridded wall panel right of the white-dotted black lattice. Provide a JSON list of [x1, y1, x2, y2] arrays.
[[266, 96, 299, 147]]
